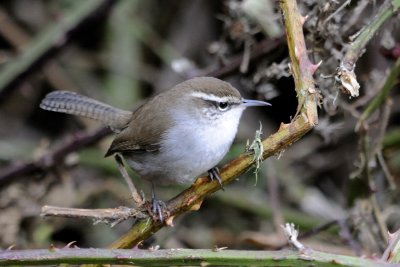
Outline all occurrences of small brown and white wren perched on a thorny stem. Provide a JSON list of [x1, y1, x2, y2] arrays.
[[40, 77, 270, 214]]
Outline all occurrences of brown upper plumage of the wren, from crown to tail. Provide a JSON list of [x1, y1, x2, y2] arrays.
[[40, 77, 241, 156]]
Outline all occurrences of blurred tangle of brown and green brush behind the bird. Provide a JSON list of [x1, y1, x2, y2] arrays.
[[0, 0, 400, 255]]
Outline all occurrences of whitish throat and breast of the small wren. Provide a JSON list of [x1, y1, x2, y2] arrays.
[[160, 107, 243, 183]]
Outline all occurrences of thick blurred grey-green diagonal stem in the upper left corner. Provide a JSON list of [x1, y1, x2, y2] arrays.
[[0, 0, 116, 104]]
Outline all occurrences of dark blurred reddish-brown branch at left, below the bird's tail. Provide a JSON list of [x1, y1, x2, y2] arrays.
[[0, 128, 111, 187]]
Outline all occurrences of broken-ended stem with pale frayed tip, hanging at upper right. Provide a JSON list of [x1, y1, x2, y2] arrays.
[[337, 0, 400, 97]]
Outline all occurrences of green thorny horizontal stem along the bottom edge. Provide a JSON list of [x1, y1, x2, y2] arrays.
[[0, 247, 397, 267]]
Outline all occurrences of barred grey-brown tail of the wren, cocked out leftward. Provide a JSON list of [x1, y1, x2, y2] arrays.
[[40, 91, 132, 131]]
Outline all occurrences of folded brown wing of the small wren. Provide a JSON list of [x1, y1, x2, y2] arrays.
[[105, 91, 172, 157]]
